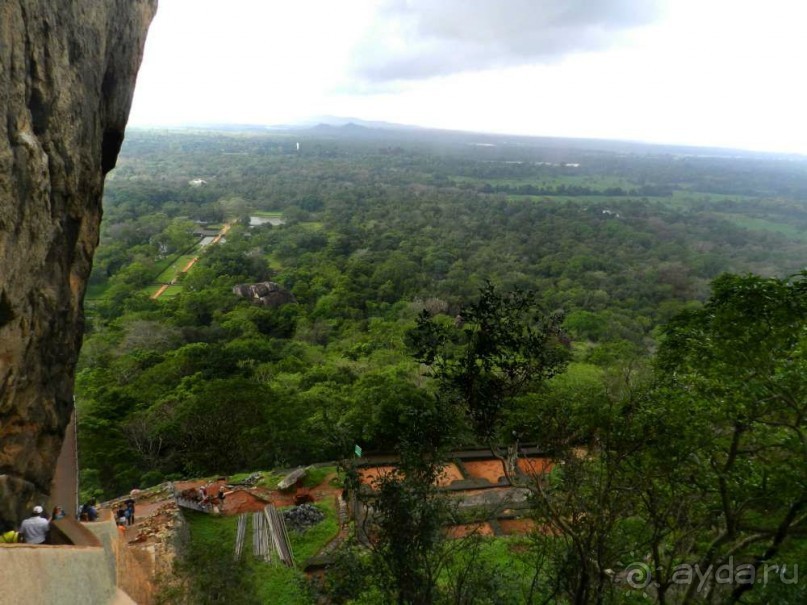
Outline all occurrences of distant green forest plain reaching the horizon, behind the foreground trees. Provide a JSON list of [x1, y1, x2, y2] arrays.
[[77, 129, 807, 493]]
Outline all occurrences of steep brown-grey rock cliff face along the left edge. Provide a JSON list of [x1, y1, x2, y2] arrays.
[[0, 0, 157, 521]]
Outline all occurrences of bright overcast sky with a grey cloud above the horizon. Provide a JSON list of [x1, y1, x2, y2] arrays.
[[130, 0, 807, 154]]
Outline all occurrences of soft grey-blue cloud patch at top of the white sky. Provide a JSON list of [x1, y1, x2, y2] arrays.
[[353, 0, 660, 82]]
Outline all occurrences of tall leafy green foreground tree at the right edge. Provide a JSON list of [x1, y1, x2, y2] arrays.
[[659, 271, 807, 603]]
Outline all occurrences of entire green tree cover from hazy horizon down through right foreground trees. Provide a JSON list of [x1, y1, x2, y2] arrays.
[[76, 129, 807, 603]]
